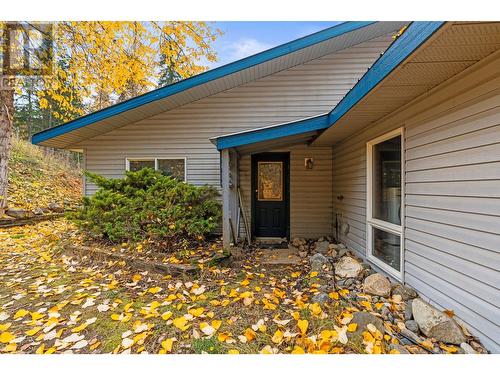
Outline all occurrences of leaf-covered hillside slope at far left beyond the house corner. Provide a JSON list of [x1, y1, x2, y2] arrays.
[[7, 138, 82, 217]]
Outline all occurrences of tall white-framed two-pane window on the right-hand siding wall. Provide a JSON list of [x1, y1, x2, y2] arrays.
[[366, 128, 403, 279]]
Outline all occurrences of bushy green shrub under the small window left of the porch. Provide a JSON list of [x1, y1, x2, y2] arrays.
[[72, 168, 220, 245]]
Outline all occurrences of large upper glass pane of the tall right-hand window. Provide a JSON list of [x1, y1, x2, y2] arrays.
[[372, 136, 401, 225]]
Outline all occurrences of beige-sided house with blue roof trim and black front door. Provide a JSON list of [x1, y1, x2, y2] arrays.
[[33, 22, 500, 352]]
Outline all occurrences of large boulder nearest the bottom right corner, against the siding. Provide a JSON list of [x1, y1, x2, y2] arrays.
[[412, 298, 466, 345]]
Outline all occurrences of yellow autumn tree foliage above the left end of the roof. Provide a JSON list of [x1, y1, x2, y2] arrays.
[[0, 21, 221, 137]]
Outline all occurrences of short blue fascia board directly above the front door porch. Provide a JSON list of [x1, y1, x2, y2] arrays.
[[216, 114, 329, 151]]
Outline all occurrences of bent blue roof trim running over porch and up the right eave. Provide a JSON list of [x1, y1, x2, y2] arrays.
[[214, 22, 444, 150]]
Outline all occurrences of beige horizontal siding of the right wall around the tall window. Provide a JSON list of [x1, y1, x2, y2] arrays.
[[333, 52, 500, 353]]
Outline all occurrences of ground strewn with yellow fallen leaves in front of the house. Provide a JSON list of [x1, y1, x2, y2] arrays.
[[0, 220, 464, 354]]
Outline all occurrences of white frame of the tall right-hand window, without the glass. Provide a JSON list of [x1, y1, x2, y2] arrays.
[[366, 127, 405, 281]]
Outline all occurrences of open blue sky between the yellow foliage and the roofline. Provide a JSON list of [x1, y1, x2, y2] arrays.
[[208, 21, 340, 68]]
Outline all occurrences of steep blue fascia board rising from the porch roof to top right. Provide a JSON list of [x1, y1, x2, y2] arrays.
[[328, 21, 445, 126]]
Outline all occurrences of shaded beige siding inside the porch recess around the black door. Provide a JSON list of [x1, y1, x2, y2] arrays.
[[239, 146, 333, 238]]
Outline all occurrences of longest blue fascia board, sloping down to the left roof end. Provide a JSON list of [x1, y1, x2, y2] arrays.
[[31, 21, 375, 144]]
